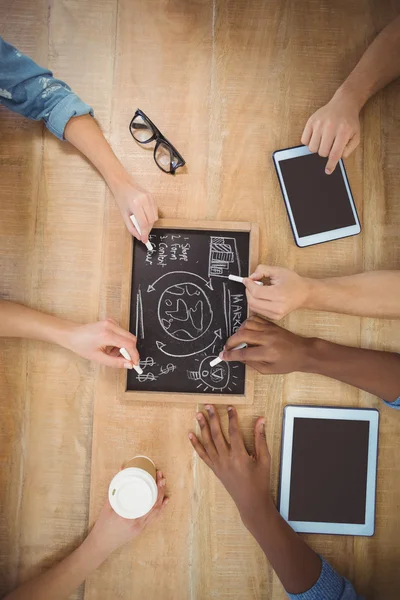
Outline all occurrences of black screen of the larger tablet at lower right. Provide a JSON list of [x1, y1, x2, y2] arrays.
[[289, 418, 369, 524]]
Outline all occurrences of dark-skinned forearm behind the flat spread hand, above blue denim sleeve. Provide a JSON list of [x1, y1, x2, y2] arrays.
[[244, 500, 321, 594]]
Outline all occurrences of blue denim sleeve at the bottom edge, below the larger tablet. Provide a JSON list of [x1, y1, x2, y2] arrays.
[[288, 558, 362, 600]]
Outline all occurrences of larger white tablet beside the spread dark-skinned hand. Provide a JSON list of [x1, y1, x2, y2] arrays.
[[279, 406, 379, 535]]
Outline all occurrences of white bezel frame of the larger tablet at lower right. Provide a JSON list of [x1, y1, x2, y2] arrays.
[[279, 406, 379, 536]]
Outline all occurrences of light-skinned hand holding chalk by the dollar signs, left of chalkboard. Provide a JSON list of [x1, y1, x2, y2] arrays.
[[61, 319, 139, 369]]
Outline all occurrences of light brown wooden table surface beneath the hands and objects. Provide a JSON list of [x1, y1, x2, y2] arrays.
[[0, 0, 400, 600]]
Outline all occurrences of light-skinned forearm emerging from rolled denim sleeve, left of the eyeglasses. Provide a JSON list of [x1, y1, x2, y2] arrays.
[[64, 115, 129, 195]]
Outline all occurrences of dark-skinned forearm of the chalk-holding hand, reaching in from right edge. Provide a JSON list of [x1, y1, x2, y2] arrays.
[[303, 338, 400, 402]]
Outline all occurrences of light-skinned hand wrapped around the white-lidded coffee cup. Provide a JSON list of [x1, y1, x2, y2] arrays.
[[87, 471, 168, 557]]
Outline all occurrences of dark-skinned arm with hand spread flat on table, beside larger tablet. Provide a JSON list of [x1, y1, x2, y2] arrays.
[[189, 405, 356, 600]]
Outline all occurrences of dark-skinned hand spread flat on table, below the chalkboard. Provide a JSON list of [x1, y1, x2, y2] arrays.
[[189, 405, 273, 528]]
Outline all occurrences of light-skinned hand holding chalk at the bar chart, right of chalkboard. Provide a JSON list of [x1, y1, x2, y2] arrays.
[[244, 265, 311, 320]]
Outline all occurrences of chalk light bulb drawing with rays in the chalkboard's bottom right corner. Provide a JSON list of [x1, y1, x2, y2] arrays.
[[186, 354, 239, 392]]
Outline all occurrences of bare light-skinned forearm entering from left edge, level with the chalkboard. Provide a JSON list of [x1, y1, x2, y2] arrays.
[[0, 300, 75, 345]]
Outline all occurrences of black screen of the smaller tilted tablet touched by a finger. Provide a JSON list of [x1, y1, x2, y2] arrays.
[[279, 154, 356, 237]]
